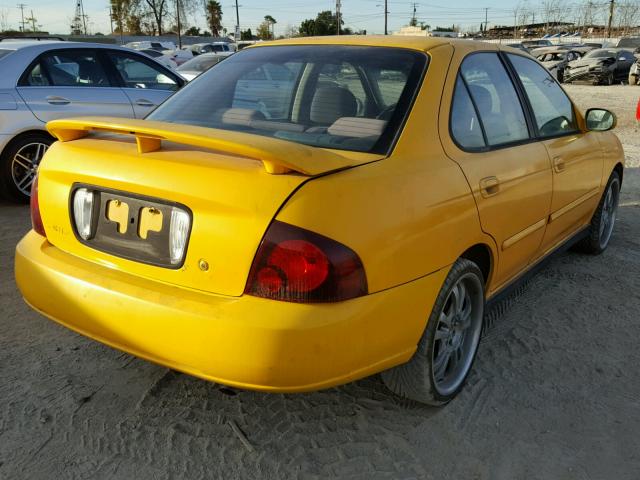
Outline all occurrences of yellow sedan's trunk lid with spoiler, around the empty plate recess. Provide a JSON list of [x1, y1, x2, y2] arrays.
[[38, 119, 381, 296]]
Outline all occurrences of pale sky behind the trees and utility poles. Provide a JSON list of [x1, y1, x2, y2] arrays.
[[0, 0, 576, 36]]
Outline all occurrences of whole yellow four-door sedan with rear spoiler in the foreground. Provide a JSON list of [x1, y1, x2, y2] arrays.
[[16, 36, 624, 405]]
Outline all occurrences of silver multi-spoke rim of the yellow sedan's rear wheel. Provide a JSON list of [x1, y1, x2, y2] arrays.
[[431, 273, 484, 396]]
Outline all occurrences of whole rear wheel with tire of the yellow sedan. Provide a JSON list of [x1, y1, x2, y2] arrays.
[[381, 258, 485, 406]]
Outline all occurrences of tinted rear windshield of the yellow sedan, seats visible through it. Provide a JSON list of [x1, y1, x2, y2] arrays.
[[148, 45, 427, 153]]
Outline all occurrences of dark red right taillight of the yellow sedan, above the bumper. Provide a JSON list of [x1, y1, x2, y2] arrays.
[[245, 221, 367, 303]]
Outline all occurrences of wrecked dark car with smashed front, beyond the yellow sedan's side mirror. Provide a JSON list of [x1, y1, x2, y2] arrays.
[[564, 48, 635, 85]]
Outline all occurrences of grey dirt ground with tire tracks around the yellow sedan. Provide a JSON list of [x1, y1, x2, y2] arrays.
[[0, 86, 640, 480]]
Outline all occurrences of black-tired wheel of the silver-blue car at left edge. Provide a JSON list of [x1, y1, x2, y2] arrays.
[[0, 132, 54, 203]]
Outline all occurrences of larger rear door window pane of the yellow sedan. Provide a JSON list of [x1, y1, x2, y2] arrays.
[[460, 53, 529, 146]]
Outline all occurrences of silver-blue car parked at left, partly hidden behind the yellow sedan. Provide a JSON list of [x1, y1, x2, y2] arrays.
[[0, 41, 184, 201]]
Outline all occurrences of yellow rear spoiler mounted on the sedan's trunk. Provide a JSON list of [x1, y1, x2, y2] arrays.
[[47, 117, 381, 176]]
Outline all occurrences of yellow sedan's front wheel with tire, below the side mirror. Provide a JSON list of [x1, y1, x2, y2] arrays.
[[576, 171, 620, 255]]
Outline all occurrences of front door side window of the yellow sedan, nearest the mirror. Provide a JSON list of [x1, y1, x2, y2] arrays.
[[508, 54, 578, 138]]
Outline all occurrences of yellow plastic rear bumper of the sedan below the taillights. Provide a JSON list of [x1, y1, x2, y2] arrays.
[[15, 231, 448, 392]]
